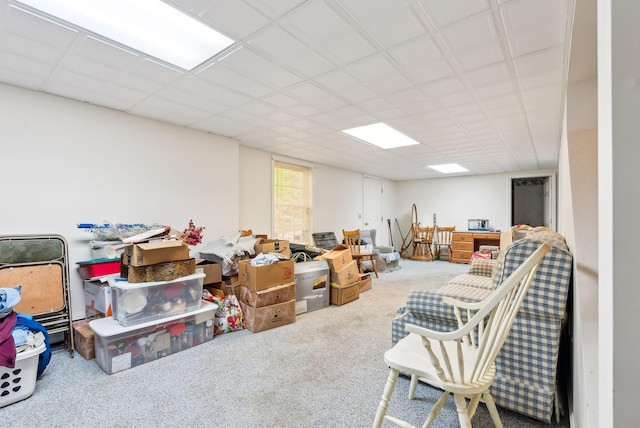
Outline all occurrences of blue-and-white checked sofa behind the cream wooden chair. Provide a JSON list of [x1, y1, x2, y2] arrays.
[[392, 230, 573, 423]]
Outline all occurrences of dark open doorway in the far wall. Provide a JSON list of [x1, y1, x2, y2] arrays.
[[511, 176, 553, 228]]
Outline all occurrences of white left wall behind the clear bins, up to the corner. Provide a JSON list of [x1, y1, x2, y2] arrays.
[[0, 85, 239, 319]]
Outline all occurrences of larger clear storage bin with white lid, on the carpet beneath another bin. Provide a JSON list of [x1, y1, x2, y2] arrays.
[[89, 301, 218, 374]]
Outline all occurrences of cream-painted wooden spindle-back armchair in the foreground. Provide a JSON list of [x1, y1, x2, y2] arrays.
[[373, 244, 551, 428]]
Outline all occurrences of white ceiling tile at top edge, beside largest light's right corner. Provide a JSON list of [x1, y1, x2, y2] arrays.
[[201, 1, 269, 41]]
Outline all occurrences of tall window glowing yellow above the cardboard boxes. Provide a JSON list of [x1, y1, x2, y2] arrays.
[[272, 161, 312, 245]]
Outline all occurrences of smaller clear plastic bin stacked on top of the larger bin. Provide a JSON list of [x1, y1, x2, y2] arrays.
[[109, 272, 205, 327]]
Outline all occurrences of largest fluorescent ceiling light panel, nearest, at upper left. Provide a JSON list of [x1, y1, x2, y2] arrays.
[[19, 0, 234, 70]]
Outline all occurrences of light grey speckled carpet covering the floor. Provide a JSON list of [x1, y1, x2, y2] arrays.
[[0, 260, 569, 428]]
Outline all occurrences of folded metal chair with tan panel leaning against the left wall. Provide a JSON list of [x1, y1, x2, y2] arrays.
[[0, 235, 73, 357]]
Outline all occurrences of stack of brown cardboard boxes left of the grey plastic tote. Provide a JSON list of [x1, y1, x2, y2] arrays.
[[234, 239, 296, 333]]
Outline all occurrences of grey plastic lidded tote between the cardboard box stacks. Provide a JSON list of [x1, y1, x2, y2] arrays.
[[294, 260, 331, 315]]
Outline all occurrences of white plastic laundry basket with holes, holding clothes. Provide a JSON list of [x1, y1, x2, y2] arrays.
[[0, 343, 46, 407]]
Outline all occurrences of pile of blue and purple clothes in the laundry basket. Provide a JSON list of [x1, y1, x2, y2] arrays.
[[0, 285, 51, 377]]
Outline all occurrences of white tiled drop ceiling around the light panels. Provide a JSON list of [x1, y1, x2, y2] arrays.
[[0, 0, 574, 180]]
